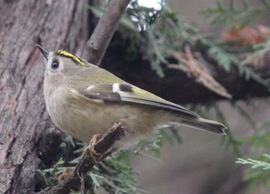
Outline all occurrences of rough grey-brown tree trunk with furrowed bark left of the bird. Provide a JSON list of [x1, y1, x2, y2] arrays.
[[0, 0, 88, 194]]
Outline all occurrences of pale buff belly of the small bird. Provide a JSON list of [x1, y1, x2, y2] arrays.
[[48, 102, 168, 148]]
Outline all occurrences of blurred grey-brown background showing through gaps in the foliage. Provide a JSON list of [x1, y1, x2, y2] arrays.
[[127, 0, 270, 194]]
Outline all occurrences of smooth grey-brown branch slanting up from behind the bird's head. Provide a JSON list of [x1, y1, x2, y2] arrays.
[[83, 0, 130, 65]]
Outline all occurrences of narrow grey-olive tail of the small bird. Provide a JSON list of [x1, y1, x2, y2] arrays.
[[178, 118, 227, 134]]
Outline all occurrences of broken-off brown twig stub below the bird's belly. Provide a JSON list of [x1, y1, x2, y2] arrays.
[[38, 123, 125, 194]]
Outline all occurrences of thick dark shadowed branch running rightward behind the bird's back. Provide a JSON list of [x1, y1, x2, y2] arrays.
[[102, 43, 270, 104]]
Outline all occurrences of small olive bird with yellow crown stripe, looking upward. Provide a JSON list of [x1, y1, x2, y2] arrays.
[[37, 45, 226, 149]]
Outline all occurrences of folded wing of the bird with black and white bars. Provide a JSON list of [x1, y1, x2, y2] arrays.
[[71, 83, 198, 118]]
